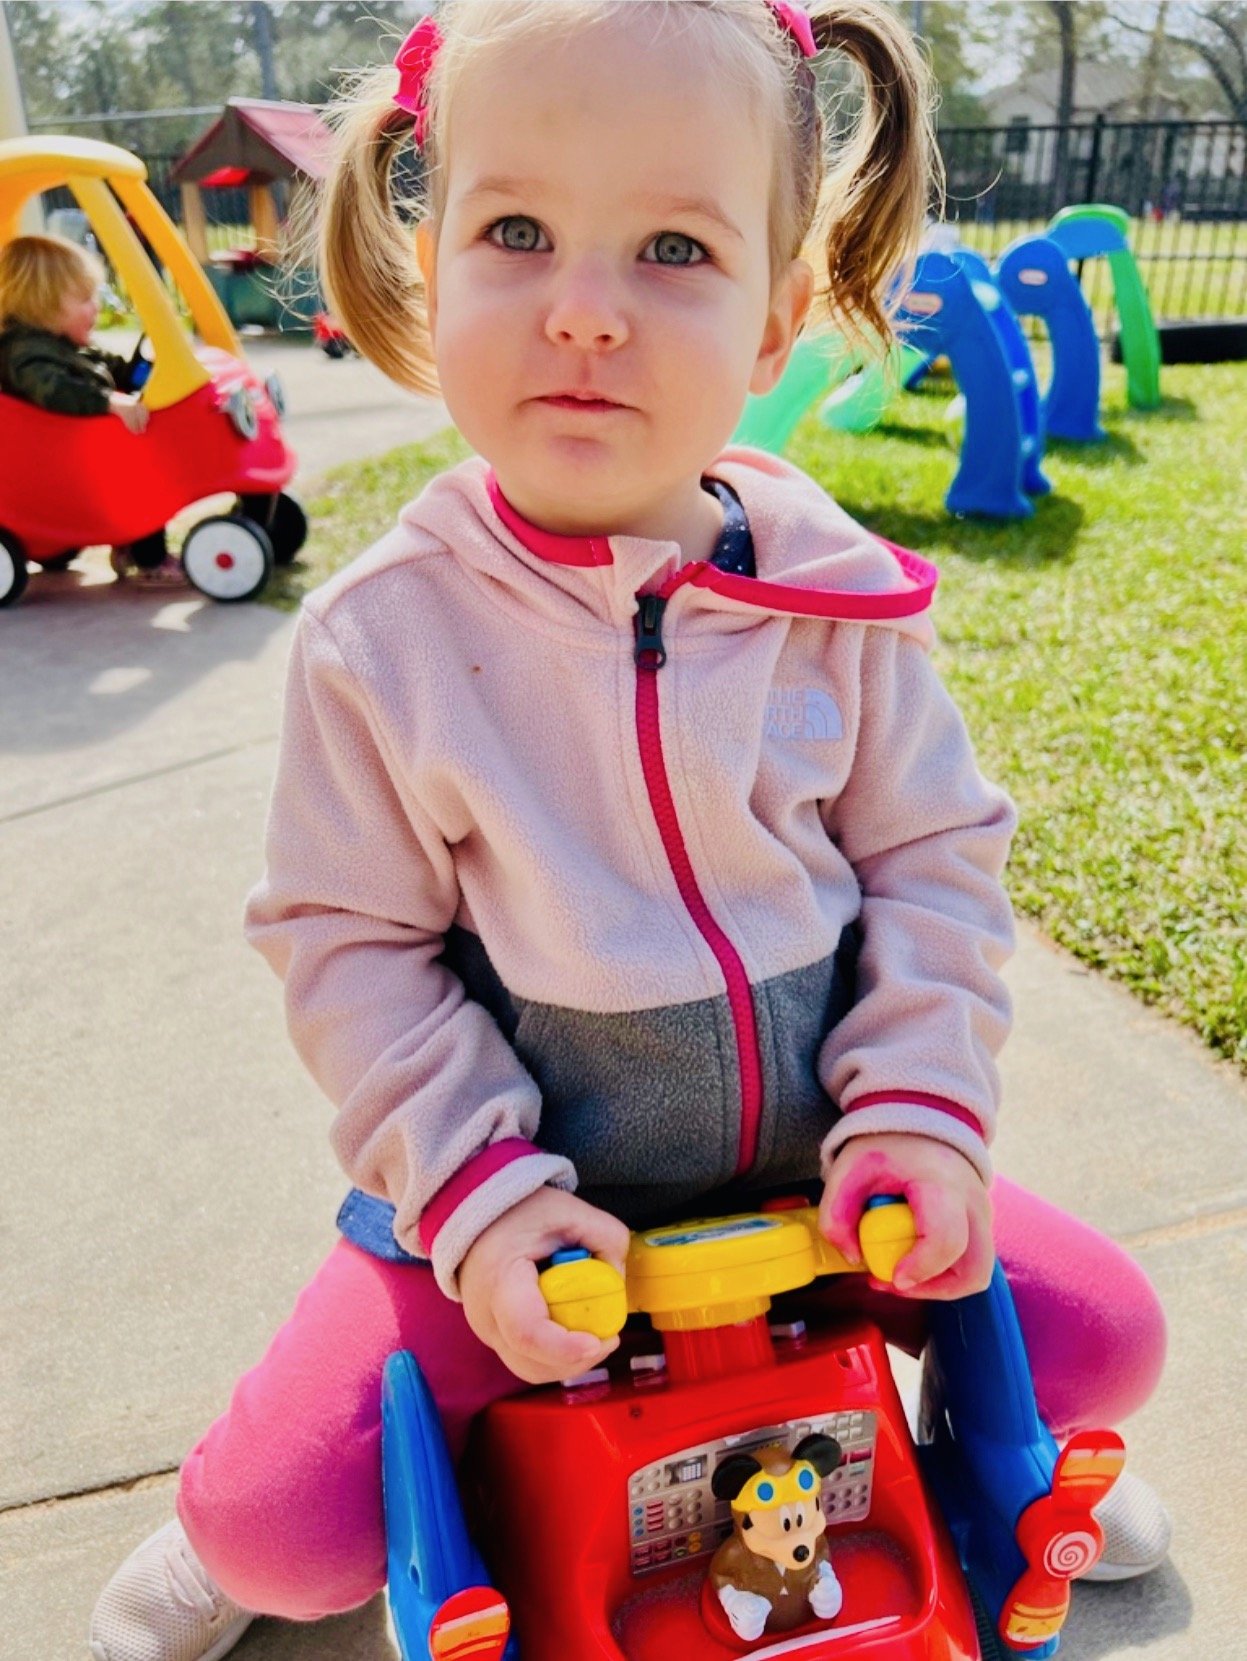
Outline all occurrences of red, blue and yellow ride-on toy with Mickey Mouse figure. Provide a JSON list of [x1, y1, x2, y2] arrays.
[[382, 1196, 1124, 1661]]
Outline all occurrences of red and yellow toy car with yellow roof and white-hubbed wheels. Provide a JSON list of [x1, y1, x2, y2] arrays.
[[0, 138, 307, 606]]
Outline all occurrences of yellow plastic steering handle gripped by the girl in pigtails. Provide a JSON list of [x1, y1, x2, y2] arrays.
[[538, 1196, 917, 1339]]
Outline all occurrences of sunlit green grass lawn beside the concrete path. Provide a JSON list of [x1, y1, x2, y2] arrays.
[[274, 365, 1247, 1070]]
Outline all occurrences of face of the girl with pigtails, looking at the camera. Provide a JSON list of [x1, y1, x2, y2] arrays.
[[417, 7, 814, 555]]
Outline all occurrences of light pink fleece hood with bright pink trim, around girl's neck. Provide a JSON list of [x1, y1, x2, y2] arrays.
[[399, 445, 938, 644]]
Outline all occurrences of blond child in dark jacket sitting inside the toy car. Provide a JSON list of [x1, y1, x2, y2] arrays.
[[0, 236, 184, 586]]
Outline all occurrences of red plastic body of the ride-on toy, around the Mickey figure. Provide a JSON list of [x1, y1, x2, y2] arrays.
[[465, 1319, 980, 1661]]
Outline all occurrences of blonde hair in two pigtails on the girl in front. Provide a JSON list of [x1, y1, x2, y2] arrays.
[[319, 0, 938, 397]]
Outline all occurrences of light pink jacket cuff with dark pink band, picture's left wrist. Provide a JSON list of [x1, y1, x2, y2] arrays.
[[411, 1136, 576, 1302]]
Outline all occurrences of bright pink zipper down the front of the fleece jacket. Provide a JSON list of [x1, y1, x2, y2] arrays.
[[636, 578, 762, 1176]]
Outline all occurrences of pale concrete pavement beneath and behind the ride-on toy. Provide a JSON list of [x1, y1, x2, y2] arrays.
[[0, 349, 1247, 1661]]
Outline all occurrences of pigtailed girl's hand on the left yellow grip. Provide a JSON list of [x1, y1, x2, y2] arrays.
[[458, 1188, 629, 1384]]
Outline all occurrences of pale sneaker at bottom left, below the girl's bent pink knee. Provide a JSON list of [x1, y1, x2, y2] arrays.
[[90, 1520, 256, 1661]]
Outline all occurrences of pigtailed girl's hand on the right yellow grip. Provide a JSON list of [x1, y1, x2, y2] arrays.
[[819, 1133, 995, 1299]]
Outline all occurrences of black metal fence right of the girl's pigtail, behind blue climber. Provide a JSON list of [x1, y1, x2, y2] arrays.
[[940, 116, 1247, 332]]
